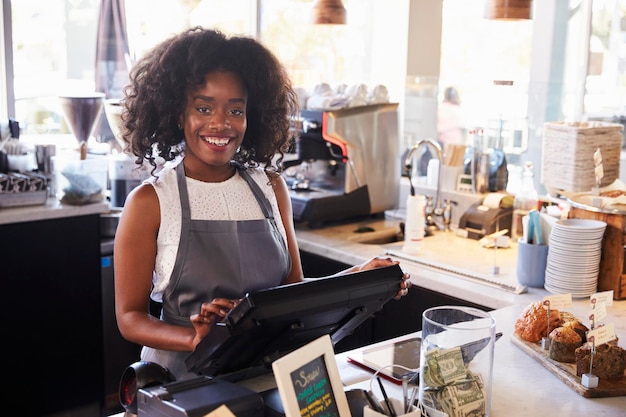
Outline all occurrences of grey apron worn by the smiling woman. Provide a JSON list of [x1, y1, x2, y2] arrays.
[[142, 162, 291, 379]]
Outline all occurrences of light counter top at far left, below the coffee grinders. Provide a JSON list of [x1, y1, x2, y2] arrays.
[[0, 198, 110, 225]]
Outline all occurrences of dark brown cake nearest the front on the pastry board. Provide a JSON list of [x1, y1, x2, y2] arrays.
[[575, 344, 626, 379]]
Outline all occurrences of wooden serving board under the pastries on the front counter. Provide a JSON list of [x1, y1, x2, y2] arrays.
[[511, 334, 626, 398]]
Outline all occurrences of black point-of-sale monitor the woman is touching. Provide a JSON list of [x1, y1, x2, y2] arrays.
[[186, 265, 403, 376]]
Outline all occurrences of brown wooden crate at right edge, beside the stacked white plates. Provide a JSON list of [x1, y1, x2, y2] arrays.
[[568, 207, 626, 300]]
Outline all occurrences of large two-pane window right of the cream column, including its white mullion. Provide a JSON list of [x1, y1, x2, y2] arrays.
[[439, 0, 626, 171]]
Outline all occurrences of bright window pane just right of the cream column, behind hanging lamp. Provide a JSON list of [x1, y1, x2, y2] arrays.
[[439, 0, 533, 164]]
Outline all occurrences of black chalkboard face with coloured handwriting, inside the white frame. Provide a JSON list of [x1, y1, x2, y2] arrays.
[[291, 356, 339, 417]]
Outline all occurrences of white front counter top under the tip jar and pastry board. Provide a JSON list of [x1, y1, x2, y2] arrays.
[[337, 301, 626, 417]]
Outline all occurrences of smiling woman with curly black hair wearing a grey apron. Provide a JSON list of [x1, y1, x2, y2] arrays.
[[114, 28, 410, 379]]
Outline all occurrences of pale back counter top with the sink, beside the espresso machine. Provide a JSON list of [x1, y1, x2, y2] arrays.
[[296, 219, 549, 309]]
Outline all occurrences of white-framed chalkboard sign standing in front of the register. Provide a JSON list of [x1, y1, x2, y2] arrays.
[[272, 335, 350, 417]]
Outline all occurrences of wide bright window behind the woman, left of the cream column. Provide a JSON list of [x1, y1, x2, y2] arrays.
[[3, 0, 408, 133]]
